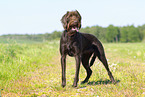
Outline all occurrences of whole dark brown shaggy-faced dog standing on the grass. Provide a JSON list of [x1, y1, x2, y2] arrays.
[[60, 10, 115, 87]]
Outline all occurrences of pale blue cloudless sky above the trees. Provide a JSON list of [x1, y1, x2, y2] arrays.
[[0, 0, 145, 35]]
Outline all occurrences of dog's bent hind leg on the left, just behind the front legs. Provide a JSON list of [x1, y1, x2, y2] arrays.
[[82, 54, 92, 84]]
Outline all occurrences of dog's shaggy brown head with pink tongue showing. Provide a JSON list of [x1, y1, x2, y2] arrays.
[[61, 10, 81, 32]]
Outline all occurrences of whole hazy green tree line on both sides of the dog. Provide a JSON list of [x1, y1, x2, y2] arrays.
[[0, 24, 145, 43]]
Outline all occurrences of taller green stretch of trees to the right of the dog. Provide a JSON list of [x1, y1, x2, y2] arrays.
[[80, 25, 145, 43]]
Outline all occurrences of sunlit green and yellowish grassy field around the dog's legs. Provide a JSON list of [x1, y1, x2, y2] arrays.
[[0, 41, 145, 97]]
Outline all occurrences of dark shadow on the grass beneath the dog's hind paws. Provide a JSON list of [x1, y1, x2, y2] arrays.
[[87, 79, 120, 85]]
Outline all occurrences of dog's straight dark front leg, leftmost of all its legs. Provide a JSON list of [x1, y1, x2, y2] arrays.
[[61, 55, 66, 87]]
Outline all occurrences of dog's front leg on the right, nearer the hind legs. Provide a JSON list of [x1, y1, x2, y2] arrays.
[[73, 55, 81, 87]]
